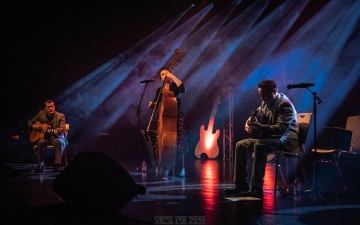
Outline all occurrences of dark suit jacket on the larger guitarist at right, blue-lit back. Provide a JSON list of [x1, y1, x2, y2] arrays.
[[259, 93, 304, 153]]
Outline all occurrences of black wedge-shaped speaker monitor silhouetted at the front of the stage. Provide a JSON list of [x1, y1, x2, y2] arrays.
[[53, 152, 138, 214]]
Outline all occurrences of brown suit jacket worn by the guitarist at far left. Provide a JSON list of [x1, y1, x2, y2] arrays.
[[27, 110, 68, 146]]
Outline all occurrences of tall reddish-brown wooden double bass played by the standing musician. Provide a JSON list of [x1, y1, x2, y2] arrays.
[[142, 49, 181, 167]]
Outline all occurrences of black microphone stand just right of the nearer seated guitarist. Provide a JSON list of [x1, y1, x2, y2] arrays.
[[305, 87, 325, 202]]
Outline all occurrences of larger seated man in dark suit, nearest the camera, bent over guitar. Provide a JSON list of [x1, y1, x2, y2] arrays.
[[225, 80, 304, 197]]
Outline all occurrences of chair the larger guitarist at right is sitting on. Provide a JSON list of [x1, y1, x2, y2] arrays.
[[274, 113, 312, 196]]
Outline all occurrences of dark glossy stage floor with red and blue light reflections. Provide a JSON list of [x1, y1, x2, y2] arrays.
[[0, 156, 360, 225]]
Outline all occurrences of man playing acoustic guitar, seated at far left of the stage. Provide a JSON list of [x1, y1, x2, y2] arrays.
[[27, 100, 68, 172]]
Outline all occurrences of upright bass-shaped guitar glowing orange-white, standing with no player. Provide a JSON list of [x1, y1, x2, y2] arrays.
[[195, 96, 221, 159]]
